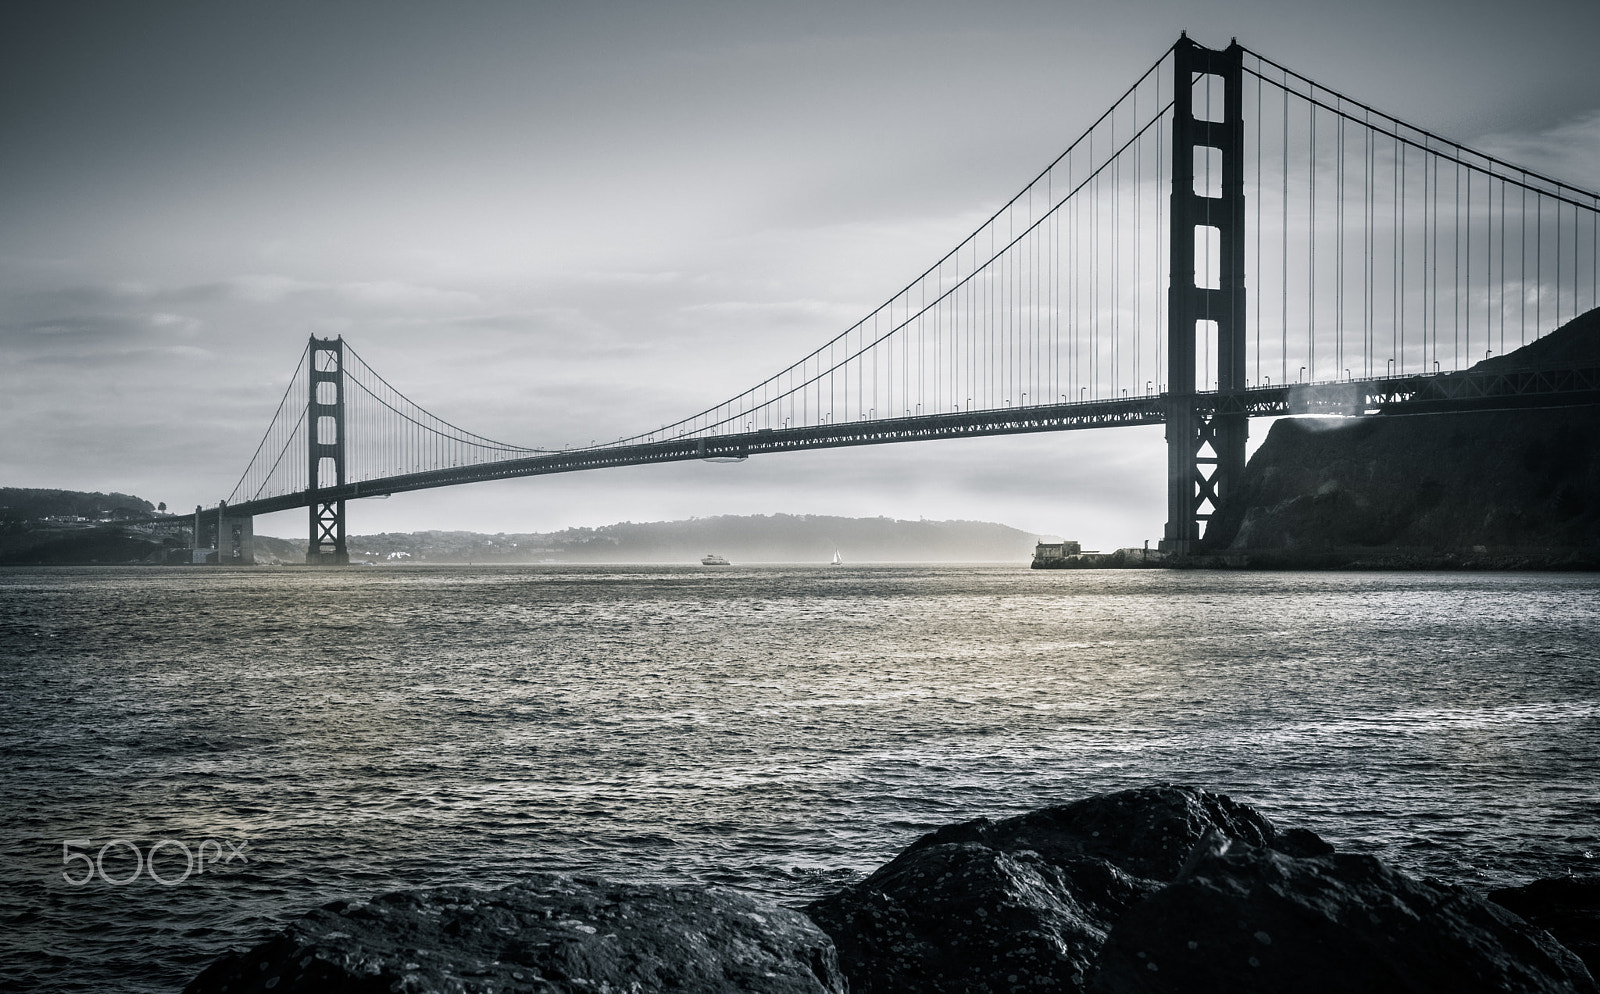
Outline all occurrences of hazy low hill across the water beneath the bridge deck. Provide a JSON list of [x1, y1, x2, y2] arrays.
[[349, 514, 1035, 563]]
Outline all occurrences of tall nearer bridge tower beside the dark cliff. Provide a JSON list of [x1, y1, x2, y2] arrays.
[[1162, 34, 1250, 554]]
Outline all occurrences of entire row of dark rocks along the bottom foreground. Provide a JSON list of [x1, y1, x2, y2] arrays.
[[186, 784, 1600, 994]]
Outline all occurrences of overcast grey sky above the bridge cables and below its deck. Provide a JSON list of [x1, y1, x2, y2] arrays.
[[0, 0, 1600, 547]]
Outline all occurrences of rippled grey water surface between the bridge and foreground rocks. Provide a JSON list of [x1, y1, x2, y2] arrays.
[[0, 567, 1600, 991]]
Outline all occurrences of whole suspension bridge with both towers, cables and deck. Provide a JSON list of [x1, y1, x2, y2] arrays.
[[181, 37, 1600, 563]]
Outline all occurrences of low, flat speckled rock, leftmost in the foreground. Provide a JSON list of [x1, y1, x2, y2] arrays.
[[186, 874, 845, 994]]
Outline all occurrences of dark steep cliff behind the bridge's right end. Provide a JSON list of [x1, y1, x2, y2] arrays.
[[1206, 311, 1600, 568]]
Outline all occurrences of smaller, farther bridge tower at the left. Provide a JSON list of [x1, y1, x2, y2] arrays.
[[306, 335, 350, 565]]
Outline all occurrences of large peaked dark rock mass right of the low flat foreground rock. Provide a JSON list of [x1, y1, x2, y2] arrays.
[[806, 784, 1600, 994]]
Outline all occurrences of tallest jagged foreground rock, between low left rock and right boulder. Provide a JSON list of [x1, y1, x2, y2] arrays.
[[806, 786, 1331, 994]]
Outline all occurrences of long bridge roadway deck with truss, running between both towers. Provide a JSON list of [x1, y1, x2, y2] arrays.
[[196, 367, 1600, 520]]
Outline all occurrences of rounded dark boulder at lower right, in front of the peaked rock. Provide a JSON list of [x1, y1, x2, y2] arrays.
[[1090, 847, 1600, 994]]
